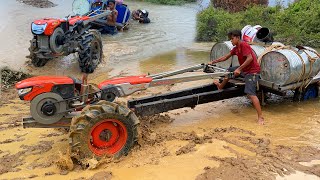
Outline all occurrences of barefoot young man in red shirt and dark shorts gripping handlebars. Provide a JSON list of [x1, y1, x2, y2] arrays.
[[208, 30, 264, 124]]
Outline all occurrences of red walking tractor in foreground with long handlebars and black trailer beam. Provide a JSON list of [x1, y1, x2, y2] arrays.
[[16, 53, 320, 165]]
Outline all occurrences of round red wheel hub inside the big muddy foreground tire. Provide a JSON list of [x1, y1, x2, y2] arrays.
[[89, 119, 128, 156]]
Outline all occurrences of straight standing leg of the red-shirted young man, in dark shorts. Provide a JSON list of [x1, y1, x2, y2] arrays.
[[244, 74, 264, 124]]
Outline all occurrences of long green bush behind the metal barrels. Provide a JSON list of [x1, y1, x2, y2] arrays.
[[197, 0, 320, 47]]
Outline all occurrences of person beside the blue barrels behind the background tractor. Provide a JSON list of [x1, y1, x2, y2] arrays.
[[101, 0, 118, 35]]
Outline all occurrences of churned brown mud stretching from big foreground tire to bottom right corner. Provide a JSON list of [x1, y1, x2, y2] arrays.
[[140, 115, 320, 180]]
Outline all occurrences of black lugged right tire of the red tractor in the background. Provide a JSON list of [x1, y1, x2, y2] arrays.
[[79, 30, 102, 73]]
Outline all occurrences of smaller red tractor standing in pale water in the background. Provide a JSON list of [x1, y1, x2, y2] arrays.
[[28, 0, 110, 73]]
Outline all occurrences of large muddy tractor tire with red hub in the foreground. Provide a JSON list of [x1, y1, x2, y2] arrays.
[[69, 101, 139, 168]]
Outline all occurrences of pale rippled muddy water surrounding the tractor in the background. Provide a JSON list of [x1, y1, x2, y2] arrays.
[[0, 0, 197, 79]]
